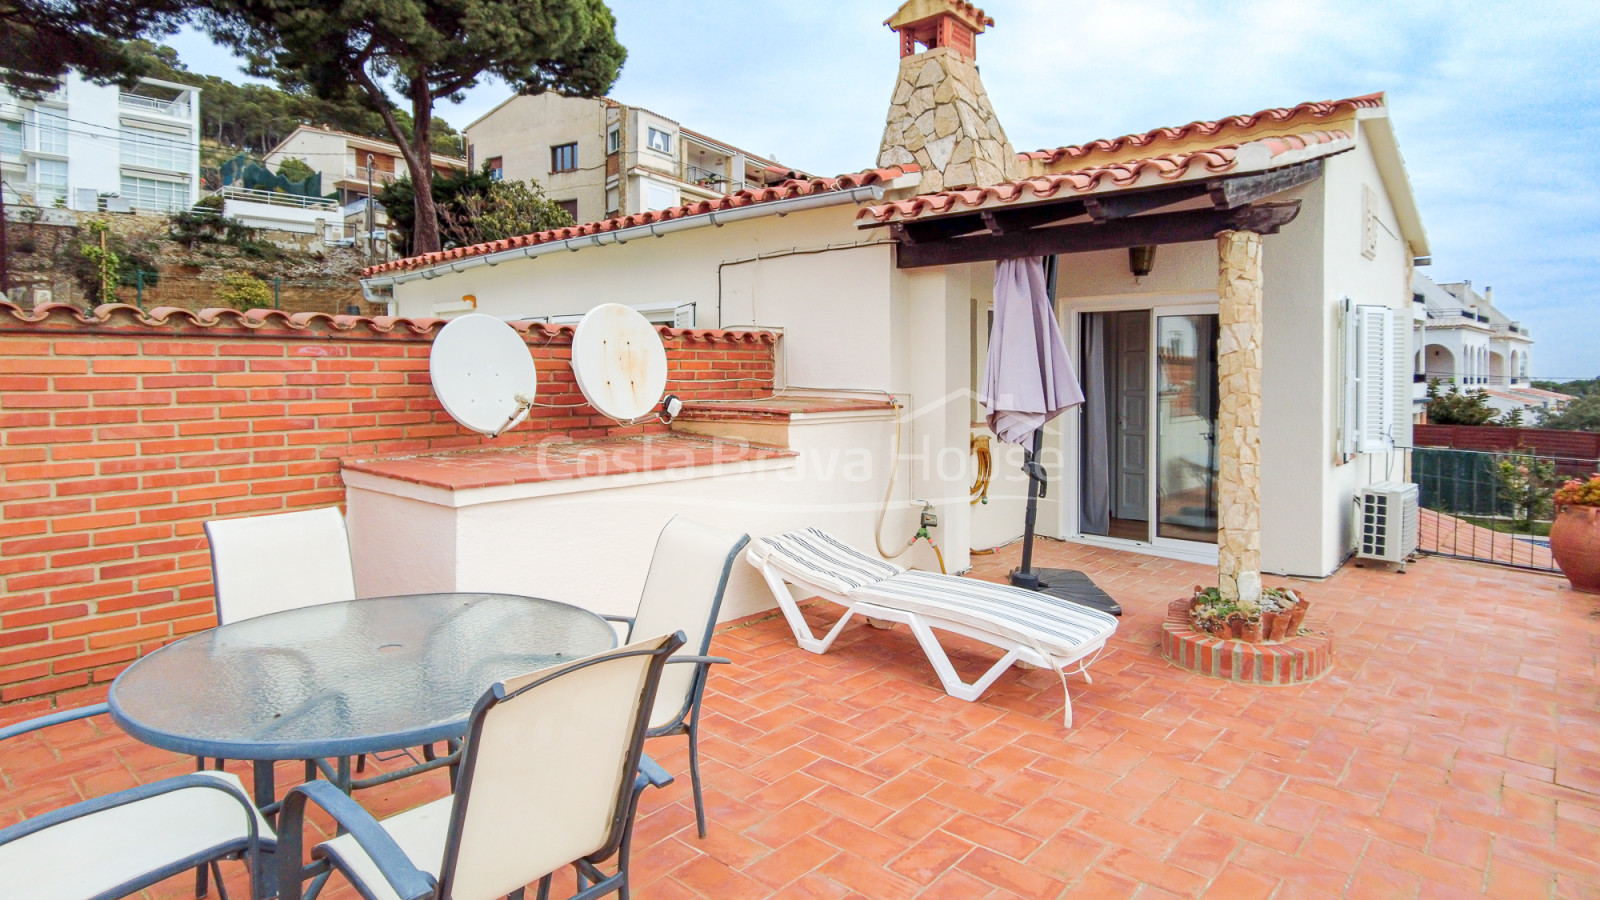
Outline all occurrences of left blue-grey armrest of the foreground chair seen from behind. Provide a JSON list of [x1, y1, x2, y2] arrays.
[[278, 781, 438, 900]]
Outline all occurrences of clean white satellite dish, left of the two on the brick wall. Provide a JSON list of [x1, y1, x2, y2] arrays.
[[427, 312, 539, 437]]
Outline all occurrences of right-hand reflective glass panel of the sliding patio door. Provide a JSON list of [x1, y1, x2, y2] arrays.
[[1155, 315, 1219, 544]]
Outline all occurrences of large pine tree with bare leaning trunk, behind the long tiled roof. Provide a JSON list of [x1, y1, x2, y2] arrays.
[[203, 0, 627, 253]]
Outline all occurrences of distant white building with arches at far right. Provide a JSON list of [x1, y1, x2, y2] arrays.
[[1411, 272, 1568, 412]]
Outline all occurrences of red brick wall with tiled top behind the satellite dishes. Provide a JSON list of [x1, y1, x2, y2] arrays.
[[0, 303, 773, 707]]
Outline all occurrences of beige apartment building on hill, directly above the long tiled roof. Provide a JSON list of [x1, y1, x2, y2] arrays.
[[466, 93, 806, 223]]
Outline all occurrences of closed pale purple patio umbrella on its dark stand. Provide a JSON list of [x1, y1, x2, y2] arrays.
[[979, 256, 1122, 615]]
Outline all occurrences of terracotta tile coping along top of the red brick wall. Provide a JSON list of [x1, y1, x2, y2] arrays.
[[0, 301, 778, 344]]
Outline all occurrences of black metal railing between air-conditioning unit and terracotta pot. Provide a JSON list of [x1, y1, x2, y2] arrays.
[[1411, 447, 1595, 572]]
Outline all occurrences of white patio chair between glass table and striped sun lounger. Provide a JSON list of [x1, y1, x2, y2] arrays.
[[605, 516, 750, 838]]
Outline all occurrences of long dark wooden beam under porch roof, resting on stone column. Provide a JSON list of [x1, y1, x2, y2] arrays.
[[894, 200, 1299, 269]]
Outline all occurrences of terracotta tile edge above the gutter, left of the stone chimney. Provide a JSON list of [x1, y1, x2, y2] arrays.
[[362, 163, 922, 279]]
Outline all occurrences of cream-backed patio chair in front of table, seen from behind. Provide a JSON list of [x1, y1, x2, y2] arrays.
[[278, 633, 683, 900]]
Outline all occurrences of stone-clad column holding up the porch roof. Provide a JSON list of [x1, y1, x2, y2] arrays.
[[1216, 231, 1261, 602]]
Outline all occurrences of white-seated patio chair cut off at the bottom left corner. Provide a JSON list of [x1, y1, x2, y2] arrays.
[[0, 703, 277, 900]]
